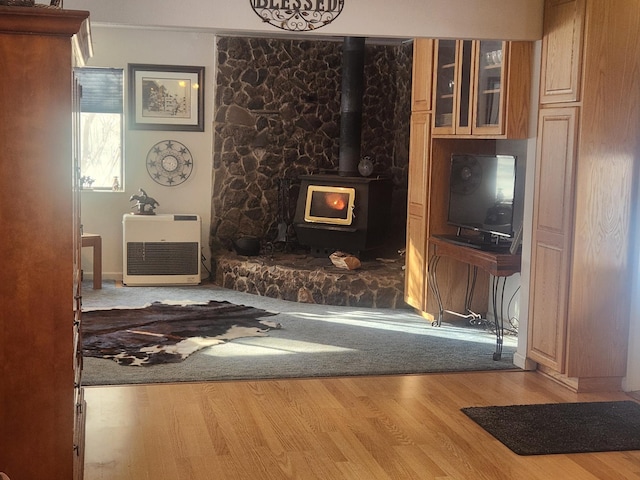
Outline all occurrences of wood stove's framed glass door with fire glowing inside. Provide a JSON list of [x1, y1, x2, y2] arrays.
[[304, 185, 356, 225]]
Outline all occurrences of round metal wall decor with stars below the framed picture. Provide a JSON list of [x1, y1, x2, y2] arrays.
[[147, 140, 193, 187]]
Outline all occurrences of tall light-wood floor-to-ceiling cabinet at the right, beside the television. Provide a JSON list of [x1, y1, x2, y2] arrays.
[[528, 0, 640, 391]]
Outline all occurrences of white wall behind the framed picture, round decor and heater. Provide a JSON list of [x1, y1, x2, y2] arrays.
[[81, 26, 215, 279]]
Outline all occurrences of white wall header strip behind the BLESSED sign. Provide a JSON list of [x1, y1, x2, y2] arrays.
[[64, 0, 543, 40]]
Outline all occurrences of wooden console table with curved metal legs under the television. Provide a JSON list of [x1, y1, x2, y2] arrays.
[[429, 236, 521, 360]]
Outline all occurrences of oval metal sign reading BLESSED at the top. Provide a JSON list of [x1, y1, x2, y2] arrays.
[[250, 0, 344, 32]]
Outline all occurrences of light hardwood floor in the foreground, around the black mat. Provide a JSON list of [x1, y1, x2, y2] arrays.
[[85, 371, 640, 480]]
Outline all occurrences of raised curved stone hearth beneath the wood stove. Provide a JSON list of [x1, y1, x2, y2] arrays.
[[215, 252, 410, 308]]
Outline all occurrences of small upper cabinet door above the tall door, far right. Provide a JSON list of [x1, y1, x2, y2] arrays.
[[540, 0, 586, 104]]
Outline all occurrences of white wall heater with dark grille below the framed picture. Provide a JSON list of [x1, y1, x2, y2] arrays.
[[122, 214, 201, 286]]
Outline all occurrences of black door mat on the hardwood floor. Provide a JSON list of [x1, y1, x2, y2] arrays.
[[462, 401, 640, 455]]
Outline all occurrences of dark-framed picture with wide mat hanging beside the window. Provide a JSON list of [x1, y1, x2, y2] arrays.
[[128, 63, 204, 132]]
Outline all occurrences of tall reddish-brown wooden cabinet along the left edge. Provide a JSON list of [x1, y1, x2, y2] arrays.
[[0, 6, 90, 479]]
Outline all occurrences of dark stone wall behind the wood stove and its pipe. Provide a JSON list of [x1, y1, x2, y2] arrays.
[[210, 37, 412, 268]]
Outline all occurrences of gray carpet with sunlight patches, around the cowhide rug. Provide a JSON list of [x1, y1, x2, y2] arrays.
[[83, 281, 517, 385]]
